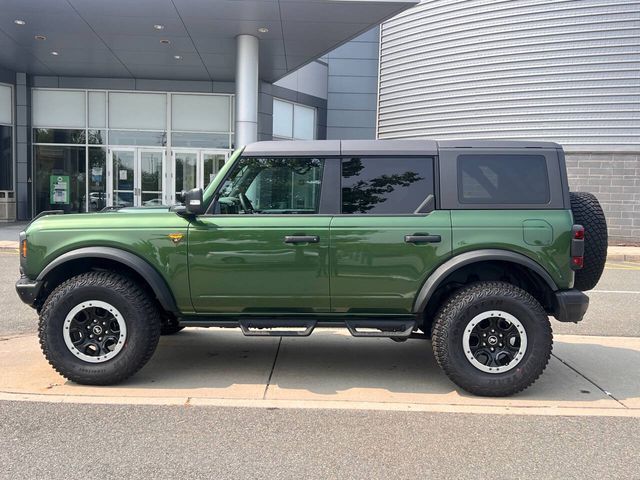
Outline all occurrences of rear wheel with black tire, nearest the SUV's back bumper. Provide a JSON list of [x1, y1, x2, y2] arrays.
[[431, 282, 553, 397]]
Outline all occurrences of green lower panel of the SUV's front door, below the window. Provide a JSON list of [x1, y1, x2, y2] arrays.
[[189, 215, 331, 314]]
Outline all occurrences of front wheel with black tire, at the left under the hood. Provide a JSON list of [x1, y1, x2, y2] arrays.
[[39, 272, 160, 385]]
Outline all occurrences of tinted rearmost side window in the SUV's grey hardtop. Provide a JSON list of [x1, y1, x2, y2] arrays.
[[458, 154, 550, 205]]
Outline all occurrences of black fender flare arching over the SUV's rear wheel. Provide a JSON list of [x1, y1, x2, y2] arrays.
[[413, 249, 558, 313]]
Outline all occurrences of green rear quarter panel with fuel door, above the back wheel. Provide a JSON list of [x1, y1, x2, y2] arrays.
[[451, 210, 574, 289]]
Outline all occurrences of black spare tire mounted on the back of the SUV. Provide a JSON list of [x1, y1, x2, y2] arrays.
[[570, 192, 608, 291]]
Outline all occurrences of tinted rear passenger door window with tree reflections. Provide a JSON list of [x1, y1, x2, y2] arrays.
[[341, 157, 434, 215]]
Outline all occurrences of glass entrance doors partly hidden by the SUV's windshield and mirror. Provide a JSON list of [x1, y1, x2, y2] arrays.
[[172, 150, 229, 200]]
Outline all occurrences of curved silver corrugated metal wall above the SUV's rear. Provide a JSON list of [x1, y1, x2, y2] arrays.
[[377, 0, 640, 147]]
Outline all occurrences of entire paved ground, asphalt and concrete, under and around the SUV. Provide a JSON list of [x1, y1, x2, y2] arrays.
[[0, 251, 640, 479]]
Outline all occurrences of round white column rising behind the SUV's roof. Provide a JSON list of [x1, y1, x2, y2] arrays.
[[235, 35, 259, 147]]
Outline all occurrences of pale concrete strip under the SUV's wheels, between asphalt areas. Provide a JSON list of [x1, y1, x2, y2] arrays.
[[0, 328, 640, 417]]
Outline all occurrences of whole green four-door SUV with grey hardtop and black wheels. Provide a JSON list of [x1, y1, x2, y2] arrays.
[[16, 140, 607, 396]]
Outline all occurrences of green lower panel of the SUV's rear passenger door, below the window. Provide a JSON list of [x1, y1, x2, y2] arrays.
[[331, 211, 451, 315]]
